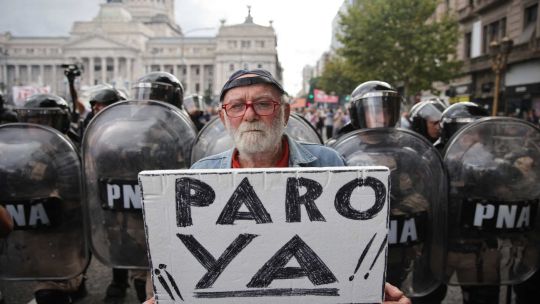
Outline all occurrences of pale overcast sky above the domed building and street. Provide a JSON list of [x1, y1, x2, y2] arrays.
[[0, 0, 343, 95]]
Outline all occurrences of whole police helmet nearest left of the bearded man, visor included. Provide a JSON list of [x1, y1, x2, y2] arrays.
[[132, 72, 184, 108]]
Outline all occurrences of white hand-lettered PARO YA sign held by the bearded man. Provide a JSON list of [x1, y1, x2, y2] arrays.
[[139, 167, 389, 303]]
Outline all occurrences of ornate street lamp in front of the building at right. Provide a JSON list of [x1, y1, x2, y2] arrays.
[[489, 36, 514, 116]]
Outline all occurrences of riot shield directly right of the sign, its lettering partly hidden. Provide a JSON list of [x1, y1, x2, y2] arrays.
[[332, 128, 447, 296]]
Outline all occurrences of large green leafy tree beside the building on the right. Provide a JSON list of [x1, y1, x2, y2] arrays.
[[336, 0, 461, 102]]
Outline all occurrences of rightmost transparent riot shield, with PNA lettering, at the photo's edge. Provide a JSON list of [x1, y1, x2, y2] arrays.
[[444, 117, 540, 285]]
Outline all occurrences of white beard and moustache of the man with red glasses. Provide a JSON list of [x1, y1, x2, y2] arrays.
[[225, 109, 285, 154]]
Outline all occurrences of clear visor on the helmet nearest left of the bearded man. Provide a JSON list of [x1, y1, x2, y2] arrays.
[[132, 82, 182, 107]]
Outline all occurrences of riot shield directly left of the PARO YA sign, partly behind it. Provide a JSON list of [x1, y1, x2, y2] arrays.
[[82, 101, 196, 268]]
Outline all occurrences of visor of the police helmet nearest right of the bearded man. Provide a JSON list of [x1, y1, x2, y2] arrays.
[[358, 92, 401, 128]]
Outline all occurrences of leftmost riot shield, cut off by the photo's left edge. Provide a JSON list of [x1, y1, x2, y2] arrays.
[[0, 123, 89, 280]]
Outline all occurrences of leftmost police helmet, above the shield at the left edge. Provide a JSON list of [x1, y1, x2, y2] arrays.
[[16, 94, 71, 134]]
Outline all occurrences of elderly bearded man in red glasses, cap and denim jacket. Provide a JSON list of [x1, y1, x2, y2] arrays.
[[146, 70, 410, 304]]
